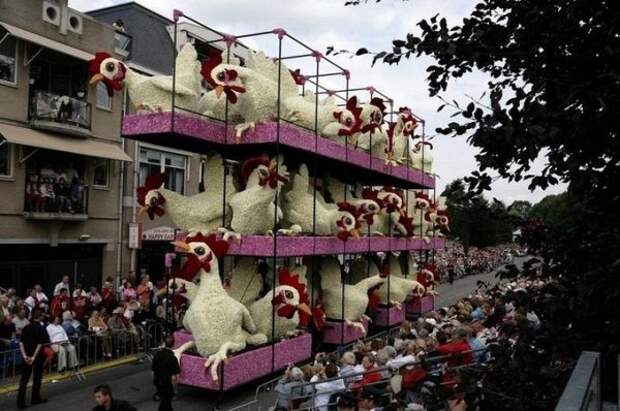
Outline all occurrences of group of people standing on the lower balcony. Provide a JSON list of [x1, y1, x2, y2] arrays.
[[25, 163, 85, 213]]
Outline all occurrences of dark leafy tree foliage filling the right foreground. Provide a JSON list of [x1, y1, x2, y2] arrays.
[[346, 0, 620, 409]]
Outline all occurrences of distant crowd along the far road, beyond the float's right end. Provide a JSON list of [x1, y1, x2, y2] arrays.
[[436, 242, 524, 282]]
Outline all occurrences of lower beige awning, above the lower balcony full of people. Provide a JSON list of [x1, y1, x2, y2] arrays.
[[0, 123, 132, 161]]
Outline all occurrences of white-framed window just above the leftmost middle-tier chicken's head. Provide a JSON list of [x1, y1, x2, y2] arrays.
[[140, 147, 187, 194]]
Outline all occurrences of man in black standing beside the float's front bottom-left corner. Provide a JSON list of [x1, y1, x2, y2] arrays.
[[152, 335, 181, 411]]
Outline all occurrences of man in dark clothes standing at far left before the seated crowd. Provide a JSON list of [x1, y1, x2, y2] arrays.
[[17, 310, 49, 409]]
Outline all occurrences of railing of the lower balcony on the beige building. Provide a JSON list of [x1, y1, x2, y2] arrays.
[[24, 183, 88, 221]]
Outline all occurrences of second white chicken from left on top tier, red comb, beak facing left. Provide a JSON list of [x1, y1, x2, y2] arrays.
[[202, 51, 298, 138]]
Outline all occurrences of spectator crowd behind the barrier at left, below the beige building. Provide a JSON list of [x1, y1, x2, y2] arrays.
[[0, 275, 174, 372]]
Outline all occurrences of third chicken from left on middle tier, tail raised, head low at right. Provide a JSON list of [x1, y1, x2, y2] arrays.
[[283, 164, 361, 240]]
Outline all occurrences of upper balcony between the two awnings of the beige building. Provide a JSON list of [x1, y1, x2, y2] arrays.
[[30, 91, 92, 137]]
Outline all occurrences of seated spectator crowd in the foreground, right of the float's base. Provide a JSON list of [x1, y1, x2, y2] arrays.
[[276, 279, 543, 411]]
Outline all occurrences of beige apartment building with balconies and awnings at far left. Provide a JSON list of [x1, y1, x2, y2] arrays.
[[0, 0, 132, 293]]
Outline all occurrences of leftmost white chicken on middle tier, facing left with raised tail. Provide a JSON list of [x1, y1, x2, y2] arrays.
[[137, 154, 236, 233]]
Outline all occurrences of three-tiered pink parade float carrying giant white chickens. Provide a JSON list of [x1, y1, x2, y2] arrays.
[[90, 10, 448, 392]]
